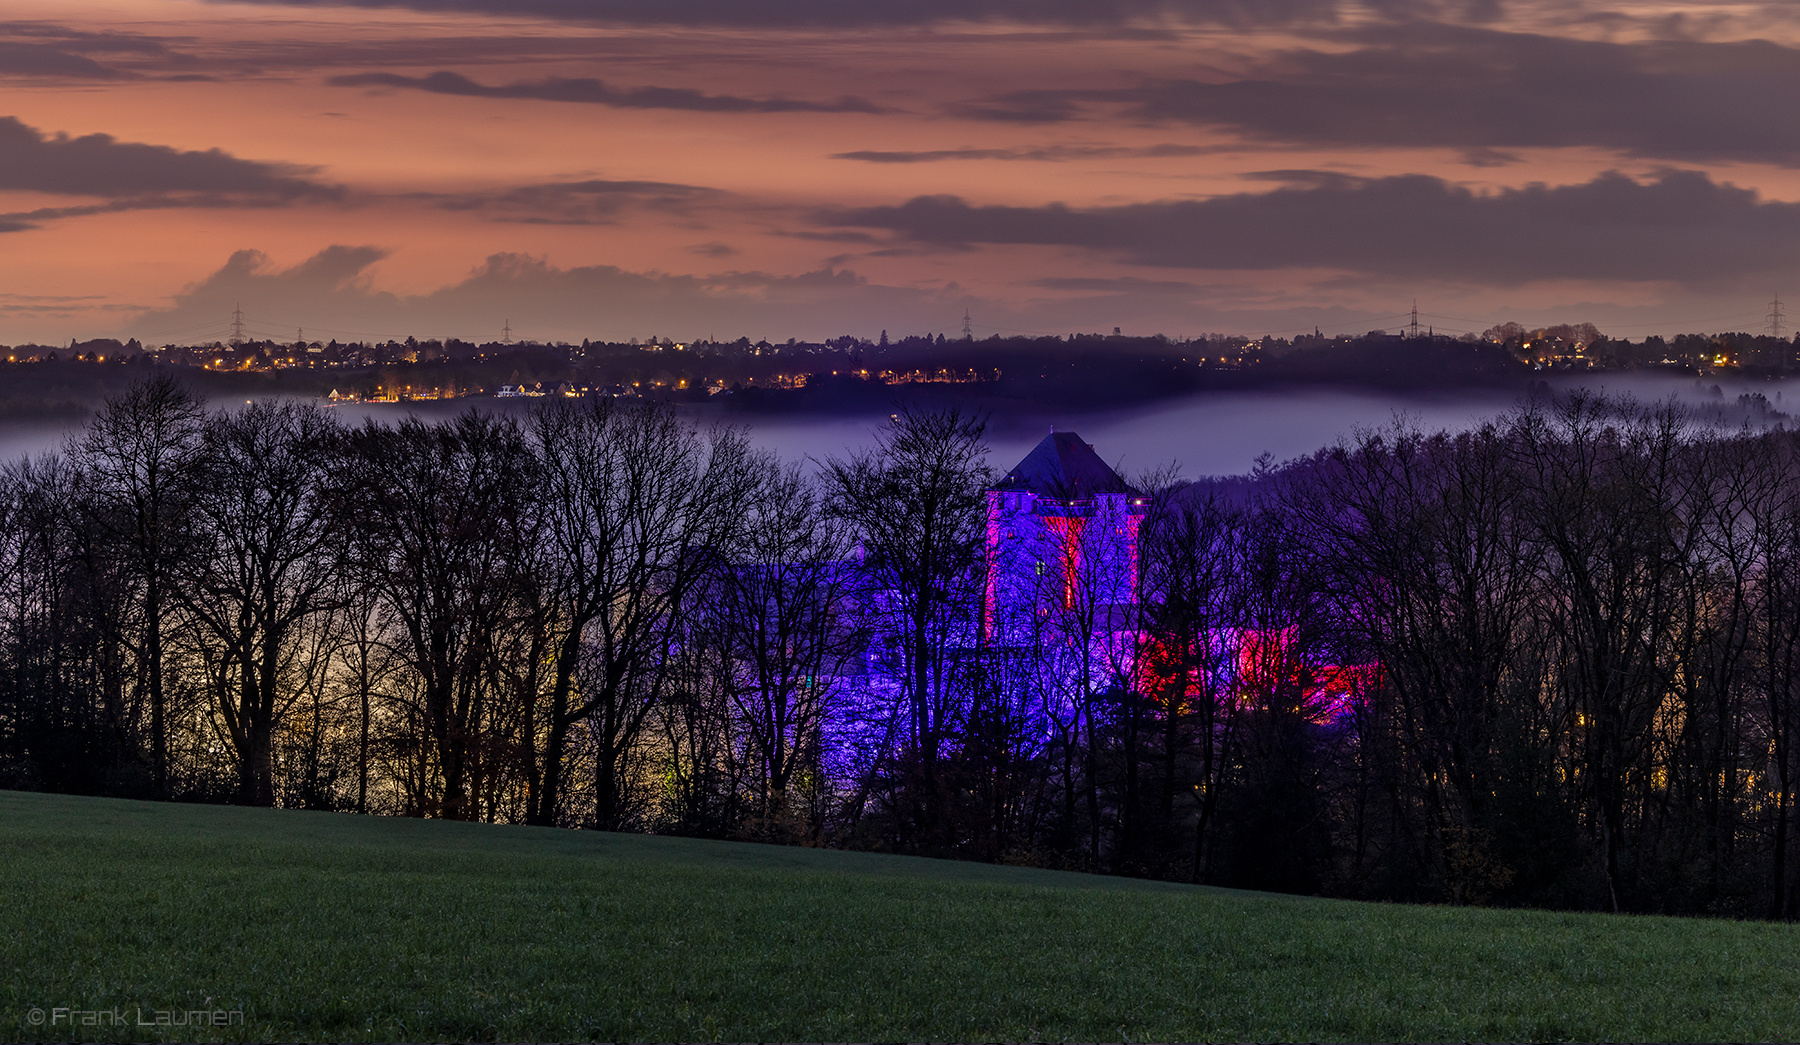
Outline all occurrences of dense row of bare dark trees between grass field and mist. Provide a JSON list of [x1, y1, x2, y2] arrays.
[[10, 378, 1800, 917]]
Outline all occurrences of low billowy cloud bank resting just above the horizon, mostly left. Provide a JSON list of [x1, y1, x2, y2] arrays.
[[119, 245, 1432, 340]]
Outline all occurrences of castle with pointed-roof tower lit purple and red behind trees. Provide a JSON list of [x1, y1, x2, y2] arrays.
[[826, 432, 1379, 794]]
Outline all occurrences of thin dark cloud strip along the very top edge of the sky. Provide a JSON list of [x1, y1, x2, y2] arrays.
[[221, 0, 1353, 27]]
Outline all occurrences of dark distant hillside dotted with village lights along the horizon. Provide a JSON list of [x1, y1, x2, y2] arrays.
[[0, 324, 1800, 414]]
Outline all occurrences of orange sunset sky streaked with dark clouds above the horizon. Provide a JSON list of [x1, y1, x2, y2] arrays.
[[0, 0, 1800, 344]]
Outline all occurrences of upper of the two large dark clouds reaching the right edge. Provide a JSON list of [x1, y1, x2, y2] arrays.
[[954, 25, 1800, 165]]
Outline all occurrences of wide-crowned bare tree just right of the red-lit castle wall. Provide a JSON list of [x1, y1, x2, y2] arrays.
[[1292, 424, 1553, 899]]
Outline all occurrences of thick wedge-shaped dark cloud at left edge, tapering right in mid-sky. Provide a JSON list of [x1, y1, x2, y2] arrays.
[[0, 117, 335, 200]]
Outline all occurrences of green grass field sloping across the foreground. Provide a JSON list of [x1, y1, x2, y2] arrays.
[[0, 791, 1800, 1041]]
